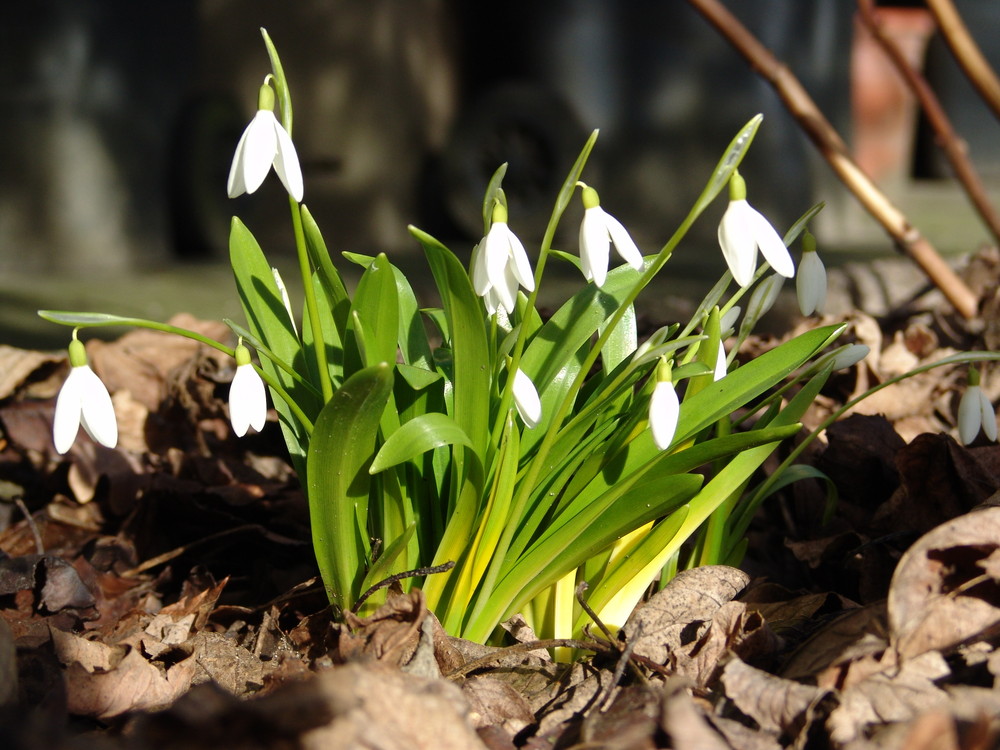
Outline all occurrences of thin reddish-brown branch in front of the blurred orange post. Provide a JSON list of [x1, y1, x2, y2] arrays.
[[858, 0, 1000, 247]]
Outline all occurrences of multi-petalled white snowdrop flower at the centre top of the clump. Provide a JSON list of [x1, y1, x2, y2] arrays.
[[470, 203, 535, 315]]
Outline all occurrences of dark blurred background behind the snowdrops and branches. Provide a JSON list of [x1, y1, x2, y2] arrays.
[[0, 0, 1000, 348]]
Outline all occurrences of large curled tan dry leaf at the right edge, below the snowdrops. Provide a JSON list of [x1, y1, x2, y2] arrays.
[[888, 507, 1000, 660]]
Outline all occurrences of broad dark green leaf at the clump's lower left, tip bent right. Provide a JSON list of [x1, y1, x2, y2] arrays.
[[306, 364, 392, 609]]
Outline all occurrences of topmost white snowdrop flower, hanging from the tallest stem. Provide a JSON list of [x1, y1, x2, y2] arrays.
[[227, 81, 303, 203]]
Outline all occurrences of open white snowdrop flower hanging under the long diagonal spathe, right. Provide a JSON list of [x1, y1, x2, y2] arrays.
[[719, 172, 795, 287]]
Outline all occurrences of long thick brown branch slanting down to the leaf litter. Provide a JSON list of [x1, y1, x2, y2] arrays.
[[688, 0, 978, 319]]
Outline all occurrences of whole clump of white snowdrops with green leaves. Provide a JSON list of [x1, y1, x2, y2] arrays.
[[40, 32, 996, 641]]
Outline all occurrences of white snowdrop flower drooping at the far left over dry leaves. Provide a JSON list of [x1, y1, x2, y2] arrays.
[[52, 340, 118, 454]]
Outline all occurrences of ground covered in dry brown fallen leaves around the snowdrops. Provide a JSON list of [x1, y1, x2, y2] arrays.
[[0, 254, 1000, 750]]
